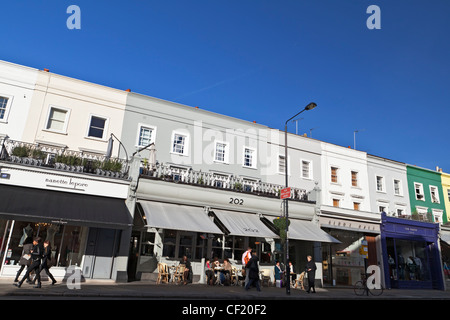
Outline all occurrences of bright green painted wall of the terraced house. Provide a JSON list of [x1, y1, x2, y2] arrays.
[[406, 165, 448, 223]]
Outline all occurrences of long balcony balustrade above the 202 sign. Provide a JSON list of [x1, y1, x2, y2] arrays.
[[139, 163, 315, 203]]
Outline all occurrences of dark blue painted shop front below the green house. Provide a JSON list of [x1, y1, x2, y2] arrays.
[[381, 213, 444, 290]]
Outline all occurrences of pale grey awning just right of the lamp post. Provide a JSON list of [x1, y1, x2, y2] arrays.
[[289, 219, 341, 243]]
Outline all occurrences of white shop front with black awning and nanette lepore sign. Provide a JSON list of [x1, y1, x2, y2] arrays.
[[0, 168, 132, 279]]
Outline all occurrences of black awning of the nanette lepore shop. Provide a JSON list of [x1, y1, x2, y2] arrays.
[[0, 184, 133, 229]]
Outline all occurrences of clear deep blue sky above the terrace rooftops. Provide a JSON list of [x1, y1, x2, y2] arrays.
[[0, 0, 450, 172]]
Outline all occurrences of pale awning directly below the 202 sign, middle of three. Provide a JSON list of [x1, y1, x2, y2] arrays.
[[212, 210, 278, 238]]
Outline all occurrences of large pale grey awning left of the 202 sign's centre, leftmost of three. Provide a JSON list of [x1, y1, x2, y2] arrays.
[[138, 200, 223, 234]]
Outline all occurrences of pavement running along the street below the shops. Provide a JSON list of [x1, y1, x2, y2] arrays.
[[0, 279, 450, 300]]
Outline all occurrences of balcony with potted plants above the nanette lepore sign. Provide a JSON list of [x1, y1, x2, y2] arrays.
[[0, 139, 128, 179]]
